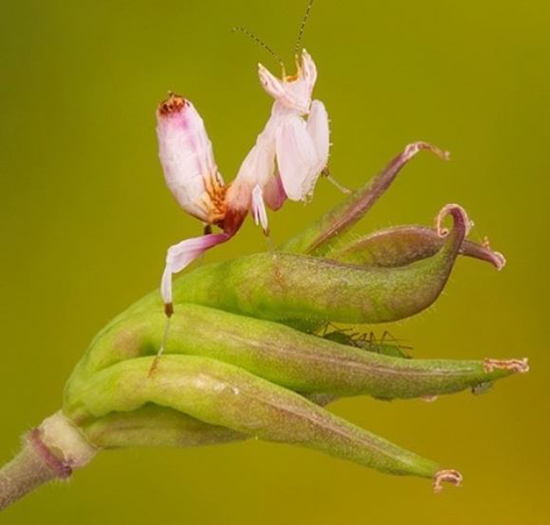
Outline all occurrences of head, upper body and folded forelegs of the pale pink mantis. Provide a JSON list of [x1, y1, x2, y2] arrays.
[[236, 49, 329, 229]]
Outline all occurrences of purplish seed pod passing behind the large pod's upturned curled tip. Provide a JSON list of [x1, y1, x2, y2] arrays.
[[330, 225, 506, 270]]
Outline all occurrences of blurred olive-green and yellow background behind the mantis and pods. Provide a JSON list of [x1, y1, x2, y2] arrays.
[[0, 0, 550, 525]]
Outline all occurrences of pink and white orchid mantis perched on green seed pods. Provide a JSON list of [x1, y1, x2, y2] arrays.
[[157, 50, 329, 317]]
